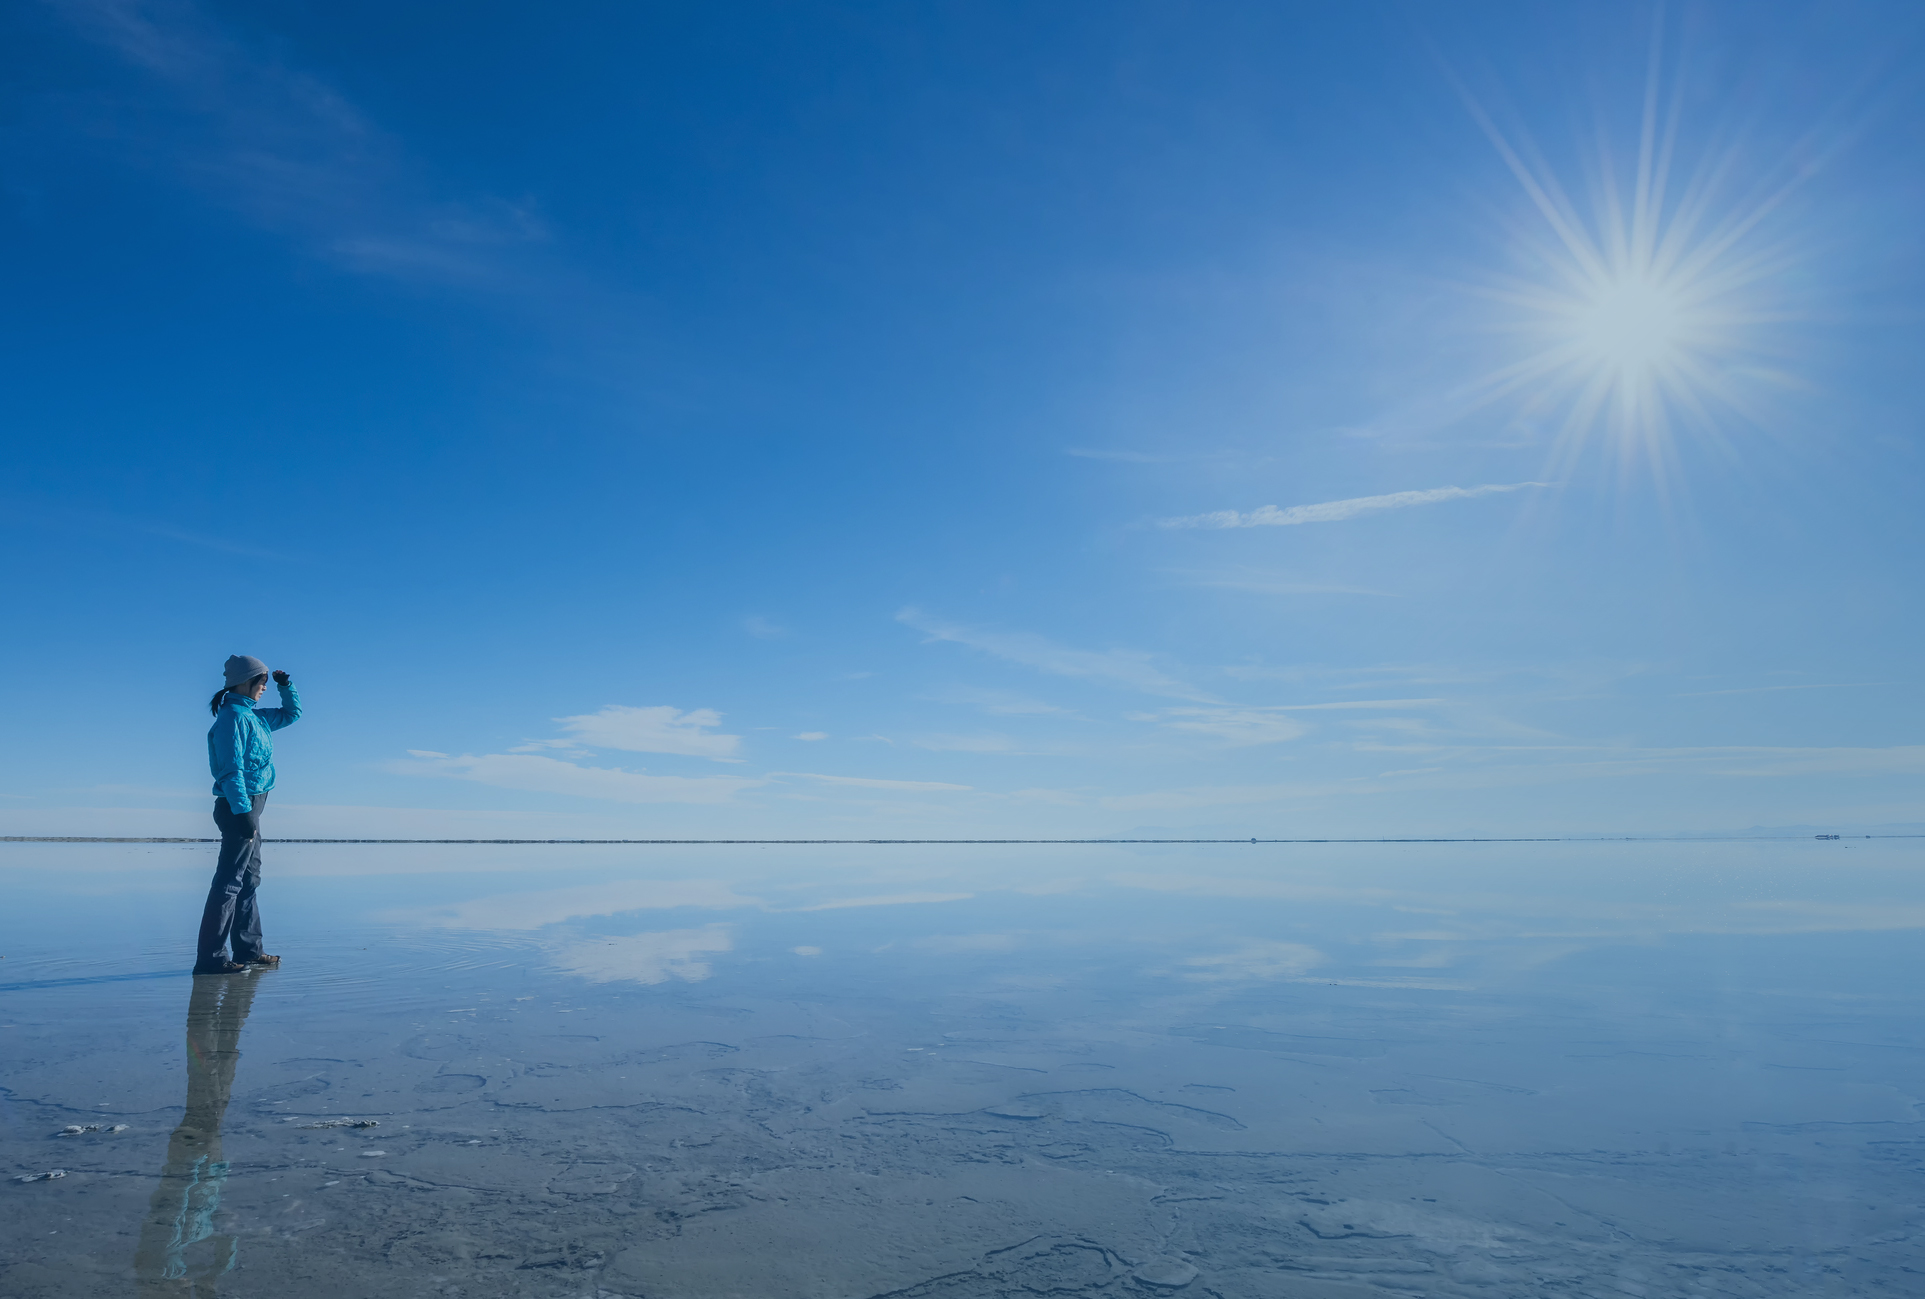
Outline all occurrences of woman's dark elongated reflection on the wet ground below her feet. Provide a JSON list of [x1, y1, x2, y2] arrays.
[[133, 980, 256, 1299]]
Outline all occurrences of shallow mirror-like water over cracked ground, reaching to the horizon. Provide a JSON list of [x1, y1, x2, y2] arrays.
[[0, 841, 1925, 1299]]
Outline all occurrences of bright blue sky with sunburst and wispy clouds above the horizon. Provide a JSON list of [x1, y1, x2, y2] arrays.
[[0, 0, 1925, 837]]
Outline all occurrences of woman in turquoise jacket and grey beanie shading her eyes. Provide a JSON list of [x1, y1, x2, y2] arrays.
[[194, 654, 300, 974]]
